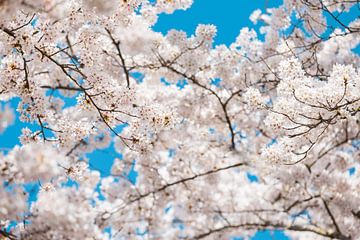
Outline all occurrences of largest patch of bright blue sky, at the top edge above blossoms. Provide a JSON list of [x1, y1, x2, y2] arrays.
[[154, 0, 282, 45]]
